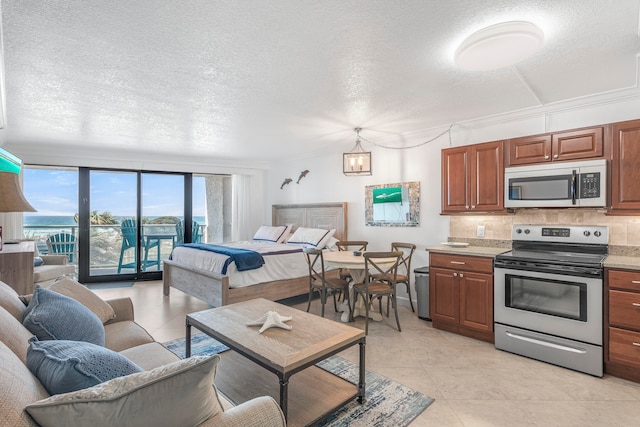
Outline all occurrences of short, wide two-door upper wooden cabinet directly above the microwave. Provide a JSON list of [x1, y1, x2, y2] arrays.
[[507, 127, 604, 166]]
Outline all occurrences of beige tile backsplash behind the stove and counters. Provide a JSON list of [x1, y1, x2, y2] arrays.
[[449, 208, 640, 247]]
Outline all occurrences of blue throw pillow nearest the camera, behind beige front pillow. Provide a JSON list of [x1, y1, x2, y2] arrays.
[[27, 337, 142, 394]]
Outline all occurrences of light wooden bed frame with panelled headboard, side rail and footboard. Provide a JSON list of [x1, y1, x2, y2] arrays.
[[163, 202, 347, 307]]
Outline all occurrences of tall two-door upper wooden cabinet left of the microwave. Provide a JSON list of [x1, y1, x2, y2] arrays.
[[442, 141, 504, 214]]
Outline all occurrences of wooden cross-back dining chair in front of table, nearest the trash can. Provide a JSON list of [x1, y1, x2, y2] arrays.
[[351, 251, 403, 334]]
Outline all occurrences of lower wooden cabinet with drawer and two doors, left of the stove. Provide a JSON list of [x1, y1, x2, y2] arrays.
[[429, 253, 494, 342]]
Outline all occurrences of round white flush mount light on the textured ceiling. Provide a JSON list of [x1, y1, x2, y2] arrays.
[[454, 21, 544, 71]]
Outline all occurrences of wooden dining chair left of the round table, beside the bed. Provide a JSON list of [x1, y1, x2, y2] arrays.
[[302, 248, 350, 317]]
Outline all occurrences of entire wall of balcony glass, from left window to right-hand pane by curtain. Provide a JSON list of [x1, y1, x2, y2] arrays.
[[23, 165, 222, 283]]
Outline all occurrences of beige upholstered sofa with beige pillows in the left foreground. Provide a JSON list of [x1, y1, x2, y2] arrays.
[[0, 278, 286, 427]]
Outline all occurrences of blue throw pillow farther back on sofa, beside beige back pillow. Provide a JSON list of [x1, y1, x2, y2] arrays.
[[22, 285, 104, 346]]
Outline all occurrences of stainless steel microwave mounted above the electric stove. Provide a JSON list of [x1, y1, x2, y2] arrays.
[[504, 159, 607, 208]]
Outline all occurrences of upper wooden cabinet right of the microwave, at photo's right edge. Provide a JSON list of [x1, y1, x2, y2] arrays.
[[608, 120, 640, 214]]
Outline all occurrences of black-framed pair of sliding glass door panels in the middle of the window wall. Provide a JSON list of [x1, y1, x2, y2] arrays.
[[79, 168, 185, 282]]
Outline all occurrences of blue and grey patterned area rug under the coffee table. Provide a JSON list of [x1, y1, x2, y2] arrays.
[[163, 333, 434, 427]]
